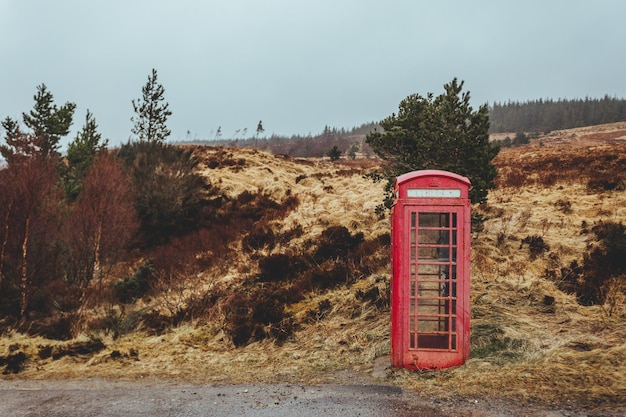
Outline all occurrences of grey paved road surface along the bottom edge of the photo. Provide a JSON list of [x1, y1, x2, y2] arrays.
[[0, 380, 446, 417]]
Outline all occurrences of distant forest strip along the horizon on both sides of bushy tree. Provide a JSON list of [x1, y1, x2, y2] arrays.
[[182, 95, 626, 159]]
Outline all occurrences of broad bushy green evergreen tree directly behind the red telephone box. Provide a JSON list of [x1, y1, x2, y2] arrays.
[[366, 78, 499, 209]]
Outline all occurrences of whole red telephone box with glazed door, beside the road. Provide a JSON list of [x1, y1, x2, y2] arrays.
[[391, 170, 470, 369]]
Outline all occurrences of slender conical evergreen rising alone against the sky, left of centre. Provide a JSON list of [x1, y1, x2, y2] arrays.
[[130, 69, 172, 143]]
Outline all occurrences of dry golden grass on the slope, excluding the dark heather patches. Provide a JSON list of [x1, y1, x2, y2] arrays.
[[0, 124, 626, 407]]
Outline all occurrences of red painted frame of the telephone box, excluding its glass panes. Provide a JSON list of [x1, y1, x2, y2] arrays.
[[390, 170, 470, 370]]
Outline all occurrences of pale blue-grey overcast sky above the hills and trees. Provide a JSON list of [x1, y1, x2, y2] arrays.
[[0, 0, 626, 145]]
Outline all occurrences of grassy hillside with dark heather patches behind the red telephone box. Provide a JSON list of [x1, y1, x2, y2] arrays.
[[0, 124, 626, 407]]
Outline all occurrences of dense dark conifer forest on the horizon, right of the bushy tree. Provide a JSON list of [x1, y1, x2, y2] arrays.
[[489, 95, 626, 133]]
